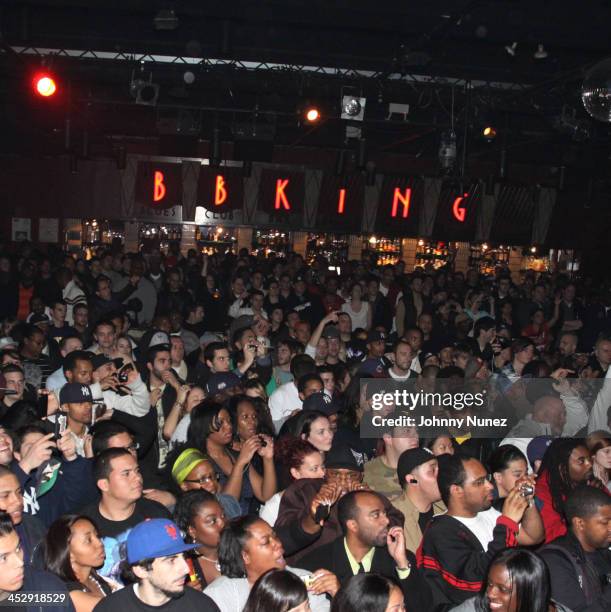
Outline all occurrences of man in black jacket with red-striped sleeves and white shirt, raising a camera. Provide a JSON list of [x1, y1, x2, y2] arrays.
[[417, 455, 545, 609]]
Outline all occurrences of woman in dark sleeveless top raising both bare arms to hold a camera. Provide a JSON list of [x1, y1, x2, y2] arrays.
[[187, 399, 276, 514]]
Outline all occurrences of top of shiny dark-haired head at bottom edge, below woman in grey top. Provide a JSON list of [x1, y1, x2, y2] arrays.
[[243, 570, 312, 612]]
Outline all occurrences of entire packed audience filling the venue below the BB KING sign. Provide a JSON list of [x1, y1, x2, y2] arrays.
[[0, 244, 611, 612]]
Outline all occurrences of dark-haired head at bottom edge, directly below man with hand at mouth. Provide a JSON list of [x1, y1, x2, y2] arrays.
[[331, 574, 405, 612]]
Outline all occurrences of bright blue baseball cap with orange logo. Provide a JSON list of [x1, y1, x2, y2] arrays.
[[127, 519, 199, 564]]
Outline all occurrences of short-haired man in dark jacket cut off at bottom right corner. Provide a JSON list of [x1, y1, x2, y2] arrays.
[[539, 485, 611, 612]]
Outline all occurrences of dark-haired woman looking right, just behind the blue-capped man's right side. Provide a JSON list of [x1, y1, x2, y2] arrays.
[[174, 490, 225, 590]]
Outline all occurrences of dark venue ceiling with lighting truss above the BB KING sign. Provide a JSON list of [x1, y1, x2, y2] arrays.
[[0, 0, 611, 184]]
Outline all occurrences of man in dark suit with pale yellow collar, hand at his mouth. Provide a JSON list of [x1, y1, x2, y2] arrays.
[[300, 491, 432, 611]]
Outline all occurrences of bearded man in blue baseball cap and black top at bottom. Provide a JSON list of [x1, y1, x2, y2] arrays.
[[95, 519, 218, 612]]
